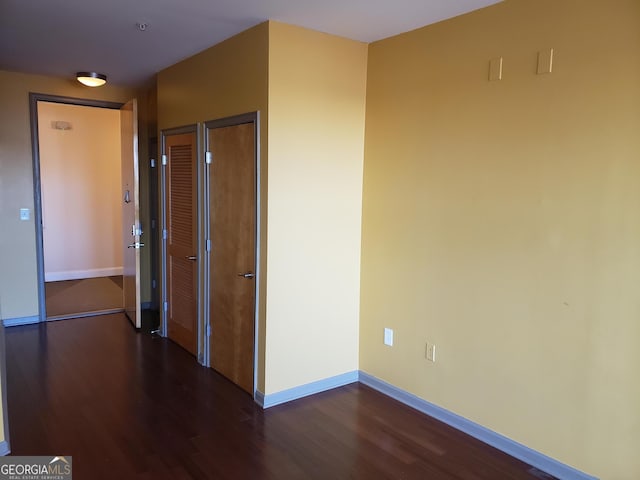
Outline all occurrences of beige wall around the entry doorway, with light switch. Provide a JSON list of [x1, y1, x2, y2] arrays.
[[0, 71, 135, 319]]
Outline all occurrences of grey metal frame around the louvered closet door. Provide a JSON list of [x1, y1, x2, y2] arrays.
[[158, 123, 205, 365]]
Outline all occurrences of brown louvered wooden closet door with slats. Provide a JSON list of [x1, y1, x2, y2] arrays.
[[165, 132, 198, 355]]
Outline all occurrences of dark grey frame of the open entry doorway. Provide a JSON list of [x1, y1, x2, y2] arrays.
[[29, 92, 124, 322]]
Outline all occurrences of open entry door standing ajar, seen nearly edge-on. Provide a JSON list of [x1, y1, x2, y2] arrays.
[[120, 99, 144, 328]]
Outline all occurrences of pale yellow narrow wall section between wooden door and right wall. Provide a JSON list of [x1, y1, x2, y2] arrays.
[[265, 22, 367, 394]]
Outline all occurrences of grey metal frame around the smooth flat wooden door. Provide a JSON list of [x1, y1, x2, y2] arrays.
[[202, 111, 262, 400]]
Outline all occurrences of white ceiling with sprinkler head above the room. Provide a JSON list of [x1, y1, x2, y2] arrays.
[[0, 0, 498, 86]]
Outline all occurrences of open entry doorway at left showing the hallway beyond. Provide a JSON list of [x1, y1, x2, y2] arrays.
[[30, 94, 141, 321]]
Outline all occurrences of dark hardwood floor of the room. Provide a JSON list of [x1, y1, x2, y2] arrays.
[[6, 314, 552, 480]]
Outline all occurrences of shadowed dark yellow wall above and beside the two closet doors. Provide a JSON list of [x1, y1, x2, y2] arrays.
[[157, 22, 269, 391]]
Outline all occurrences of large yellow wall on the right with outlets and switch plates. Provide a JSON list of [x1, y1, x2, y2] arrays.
[[360, 0, 640, 480]]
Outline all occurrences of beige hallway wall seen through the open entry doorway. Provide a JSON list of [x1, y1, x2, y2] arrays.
[[38, 102, 122, 281]]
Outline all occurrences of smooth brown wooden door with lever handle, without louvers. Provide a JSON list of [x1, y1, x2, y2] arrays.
[[208, 123, 256, 394]]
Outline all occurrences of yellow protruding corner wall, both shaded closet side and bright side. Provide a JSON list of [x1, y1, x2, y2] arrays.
[[158, 22, 367, 394]]
